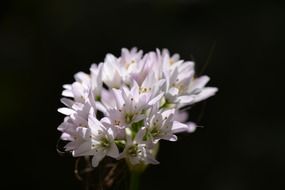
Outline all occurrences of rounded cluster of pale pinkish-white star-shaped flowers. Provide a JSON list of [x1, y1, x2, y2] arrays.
[[58, 48, 217, 167]]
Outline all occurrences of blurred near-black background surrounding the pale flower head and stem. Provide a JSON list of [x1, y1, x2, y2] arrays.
[[0, 0, 285, 190]]
